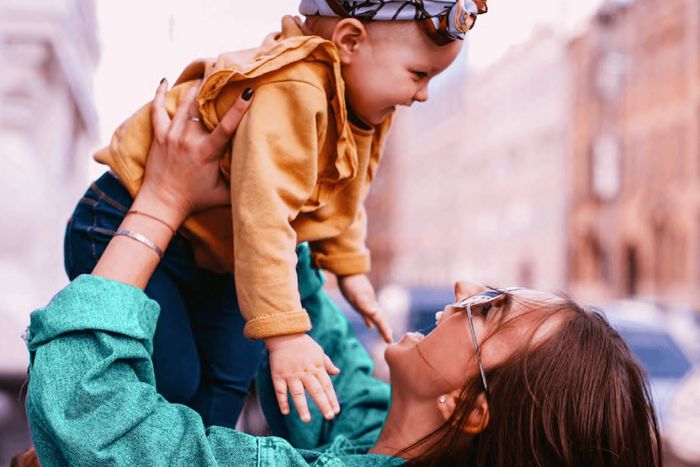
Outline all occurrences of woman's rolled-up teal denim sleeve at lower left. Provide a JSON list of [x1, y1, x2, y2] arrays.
[[27, 275, 323, 467]]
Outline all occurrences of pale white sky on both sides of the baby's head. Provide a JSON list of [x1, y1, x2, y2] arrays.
[[91, 0, 601, 176]]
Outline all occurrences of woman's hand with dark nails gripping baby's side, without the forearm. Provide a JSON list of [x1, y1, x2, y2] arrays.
[[139, 81, 252, 230]]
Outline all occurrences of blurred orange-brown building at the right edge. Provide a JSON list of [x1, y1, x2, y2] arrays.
[[569, 0, 700, 304]]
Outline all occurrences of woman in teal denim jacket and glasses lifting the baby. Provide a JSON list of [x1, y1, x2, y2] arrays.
[[21, 85, 661, 466]]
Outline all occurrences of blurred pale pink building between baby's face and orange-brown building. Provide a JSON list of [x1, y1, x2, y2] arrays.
[[368, 30, 570, 289]]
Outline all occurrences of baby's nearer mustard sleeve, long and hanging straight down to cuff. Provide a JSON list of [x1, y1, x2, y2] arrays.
[[231, 81, 328, 339]]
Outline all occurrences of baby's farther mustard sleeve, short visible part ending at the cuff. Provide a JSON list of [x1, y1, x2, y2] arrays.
[[312, 205, 370, 276]]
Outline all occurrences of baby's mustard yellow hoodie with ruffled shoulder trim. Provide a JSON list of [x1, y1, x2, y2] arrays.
[[95, 17, 391, 339]]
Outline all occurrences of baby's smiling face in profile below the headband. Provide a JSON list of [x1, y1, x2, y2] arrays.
[[343, 21, 463, 125]]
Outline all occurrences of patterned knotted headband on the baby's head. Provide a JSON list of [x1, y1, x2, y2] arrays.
[[299, 0, 487, 45]]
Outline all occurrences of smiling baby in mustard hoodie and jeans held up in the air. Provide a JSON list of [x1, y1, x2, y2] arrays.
[[66, 0, 486, 426]]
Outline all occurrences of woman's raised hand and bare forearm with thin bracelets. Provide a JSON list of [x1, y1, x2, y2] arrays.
[[92, 80, 252, 288]]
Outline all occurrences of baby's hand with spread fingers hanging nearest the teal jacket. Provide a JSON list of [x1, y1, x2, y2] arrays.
[[265, 334, 340, 422]]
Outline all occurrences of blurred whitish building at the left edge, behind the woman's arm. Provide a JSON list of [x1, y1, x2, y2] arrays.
[[0, 0, 98, 375]]
